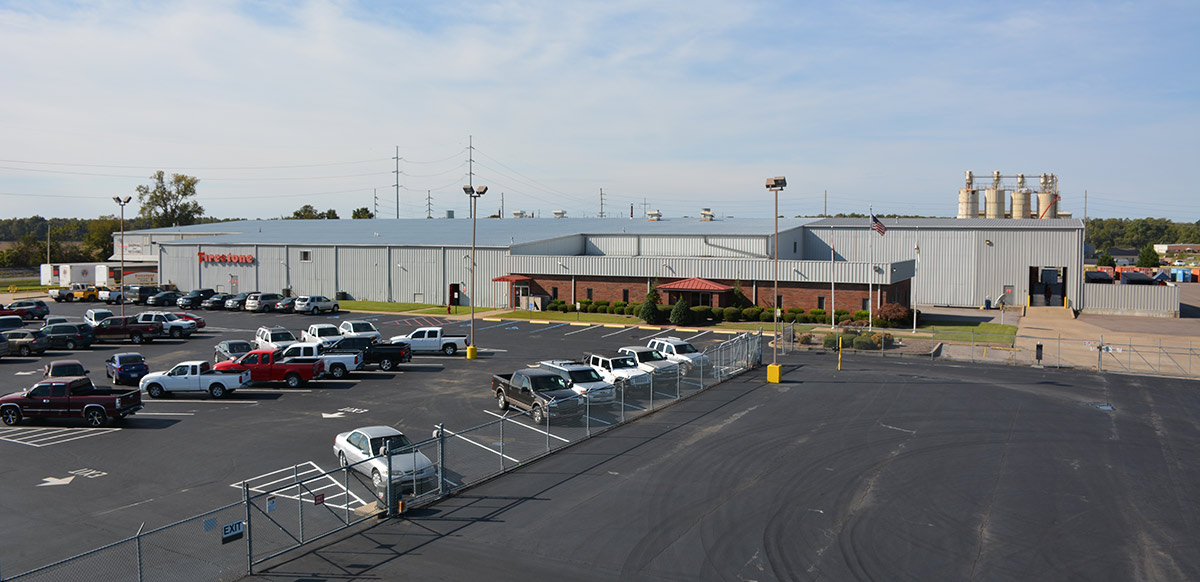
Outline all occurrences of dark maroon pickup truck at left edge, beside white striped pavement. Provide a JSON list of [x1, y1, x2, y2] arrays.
[[0, 376, 142, 426]]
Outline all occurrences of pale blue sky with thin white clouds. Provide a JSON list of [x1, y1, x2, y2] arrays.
[[0, 0, 1200, 222]]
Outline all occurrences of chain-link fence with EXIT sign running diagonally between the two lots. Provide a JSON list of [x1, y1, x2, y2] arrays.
[[0, 332, 762, 582]]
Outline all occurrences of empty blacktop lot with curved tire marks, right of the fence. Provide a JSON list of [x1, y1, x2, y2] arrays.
[[243, 353, 1200, 581]]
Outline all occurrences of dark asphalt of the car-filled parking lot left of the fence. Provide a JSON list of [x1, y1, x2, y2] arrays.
[[0, 304, 728, 576]]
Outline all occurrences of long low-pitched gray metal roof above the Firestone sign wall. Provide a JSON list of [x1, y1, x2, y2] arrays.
[[138, 218, 811, 247]]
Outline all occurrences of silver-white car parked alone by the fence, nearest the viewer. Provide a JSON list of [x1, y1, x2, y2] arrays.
[[334, 426, 438, 494]]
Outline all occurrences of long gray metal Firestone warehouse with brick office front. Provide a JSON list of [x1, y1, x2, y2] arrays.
[[113, 218, 1099, 310]]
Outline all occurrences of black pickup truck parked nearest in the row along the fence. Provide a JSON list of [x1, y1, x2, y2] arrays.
[[492, 368, 584, 425]]
